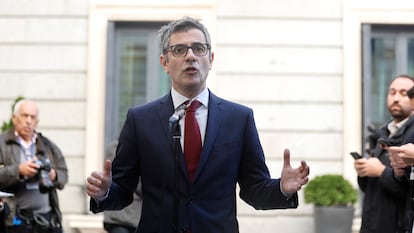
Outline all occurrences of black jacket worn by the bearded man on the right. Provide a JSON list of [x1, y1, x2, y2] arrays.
[[358, 117, 414, 233]]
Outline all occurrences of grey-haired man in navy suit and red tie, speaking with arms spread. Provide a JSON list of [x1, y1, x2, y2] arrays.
[[86, 17, 309, 233]]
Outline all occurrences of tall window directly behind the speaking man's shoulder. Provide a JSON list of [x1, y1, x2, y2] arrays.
[[105, 22, 170, 145]]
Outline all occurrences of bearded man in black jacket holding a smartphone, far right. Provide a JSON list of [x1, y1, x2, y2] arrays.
[[354, 75, 414, 233]]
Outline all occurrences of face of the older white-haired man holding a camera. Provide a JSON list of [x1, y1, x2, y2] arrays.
[[13, 101, 39, 141]]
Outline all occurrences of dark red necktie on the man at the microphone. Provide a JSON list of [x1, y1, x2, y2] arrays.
[[184, 100, 201, 182]]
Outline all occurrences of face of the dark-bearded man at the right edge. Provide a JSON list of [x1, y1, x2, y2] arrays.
[[387, 78, 414, 122]]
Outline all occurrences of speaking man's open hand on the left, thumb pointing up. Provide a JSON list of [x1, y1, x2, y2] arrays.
[[86, 160, 112, 200]]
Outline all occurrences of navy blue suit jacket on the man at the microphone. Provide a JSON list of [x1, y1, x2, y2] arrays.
[[90, 92, 298, 233]]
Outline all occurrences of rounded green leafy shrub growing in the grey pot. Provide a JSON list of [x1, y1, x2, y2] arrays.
[[304, 174, 358, 206]]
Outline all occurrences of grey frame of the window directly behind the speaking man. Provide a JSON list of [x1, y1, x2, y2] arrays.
[[104, 21, 167, 145]]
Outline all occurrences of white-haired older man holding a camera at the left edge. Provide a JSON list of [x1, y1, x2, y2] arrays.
[[0, 100, 68, 233]]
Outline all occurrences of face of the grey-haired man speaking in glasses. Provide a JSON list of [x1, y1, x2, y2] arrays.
[[160, 29, 214, 97]]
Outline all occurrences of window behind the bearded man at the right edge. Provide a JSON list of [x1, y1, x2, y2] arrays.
[[362, 24, 414, 151]]
